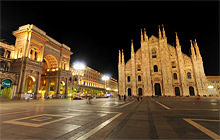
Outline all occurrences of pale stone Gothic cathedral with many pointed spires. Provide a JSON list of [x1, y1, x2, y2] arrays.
[[118, 26, 208, 96]]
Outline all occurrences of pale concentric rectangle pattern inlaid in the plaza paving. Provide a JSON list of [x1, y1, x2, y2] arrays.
[[3, 114, 78, 127]]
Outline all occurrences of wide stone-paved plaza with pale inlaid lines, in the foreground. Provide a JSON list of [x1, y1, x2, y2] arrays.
[[0, 97, 220, 140]]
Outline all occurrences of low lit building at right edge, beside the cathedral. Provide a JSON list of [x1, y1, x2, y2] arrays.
[[206, 76, 220, 95]]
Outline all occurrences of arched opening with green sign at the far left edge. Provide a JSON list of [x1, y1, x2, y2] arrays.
[[0, 79, 12, 99]]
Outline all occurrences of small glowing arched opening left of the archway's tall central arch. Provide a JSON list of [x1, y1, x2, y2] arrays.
[[24, 76, 36, 99]]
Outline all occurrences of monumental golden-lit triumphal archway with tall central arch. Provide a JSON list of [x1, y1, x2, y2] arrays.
[[11, 24, 73, 99]]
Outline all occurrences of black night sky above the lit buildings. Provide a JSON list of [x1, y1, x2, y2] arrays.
[[0, 1, 219, 78]]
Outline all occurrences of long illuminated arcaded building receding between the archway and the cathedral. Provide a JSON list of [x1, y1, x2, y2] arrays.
[[69, 66, 118, 96]]
